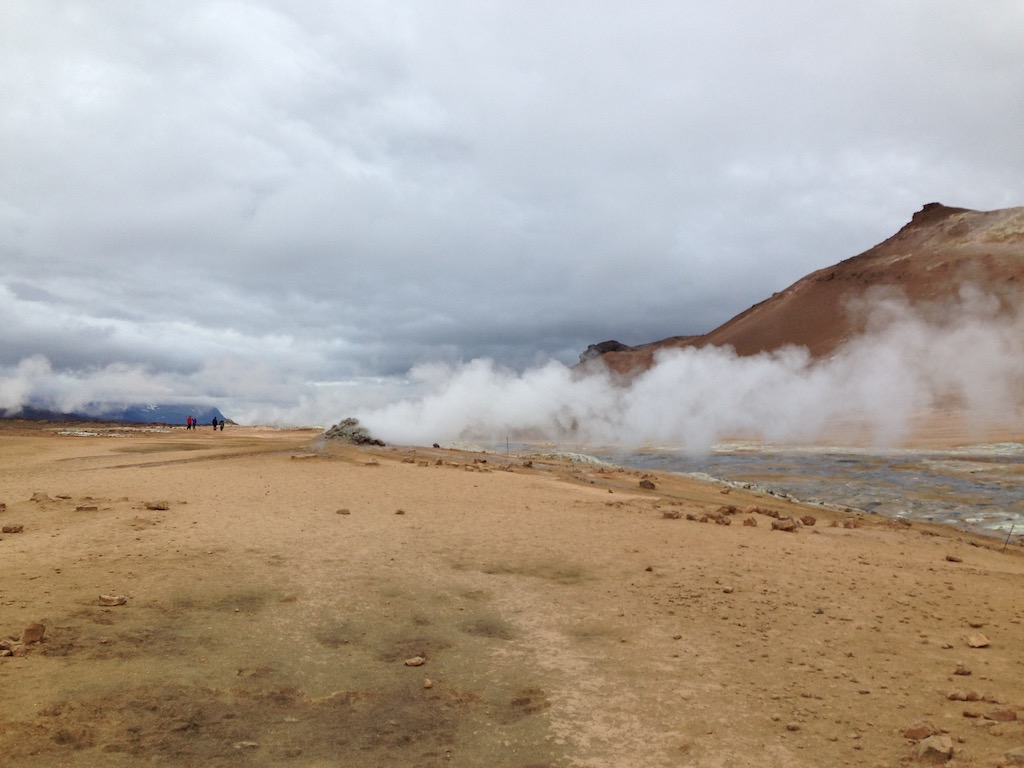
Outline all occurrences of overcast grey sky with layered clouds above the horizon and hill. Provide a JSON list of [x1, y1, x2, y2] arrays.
[[0, 0, 1024, 424]]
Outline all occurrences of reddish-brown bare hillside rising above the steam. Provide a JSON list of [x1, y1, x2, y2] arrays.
[[581, 203, 1024, 372]]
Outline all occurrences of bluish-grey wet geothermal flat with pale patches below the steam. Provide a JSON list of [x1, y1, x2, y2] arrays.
[[588, 443, 1024, 535]]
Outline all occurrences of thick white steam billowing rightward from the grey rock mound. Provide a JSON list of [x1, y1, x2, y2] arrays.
[[359, 291, 1024, 453]]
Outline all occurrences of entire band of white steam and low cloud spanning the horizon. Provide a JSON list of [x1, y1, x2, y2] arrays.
[[6, 291, 1024, 444]]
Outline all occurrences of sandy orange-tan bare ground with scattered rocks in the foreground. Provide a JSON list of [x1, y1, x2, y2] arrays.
[[0, 423, 1024, 768]]
